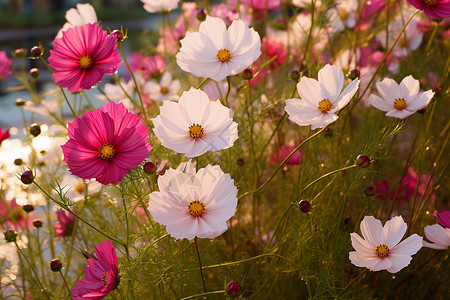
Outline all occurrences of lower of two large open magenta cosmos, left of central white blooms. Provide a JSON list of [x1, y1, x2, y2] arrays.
[[61, 102, 152, 184]]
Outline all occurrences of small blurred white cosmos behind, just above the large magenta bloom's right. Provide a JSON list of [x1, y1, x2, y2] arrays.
[[144, 72, 181, 101]]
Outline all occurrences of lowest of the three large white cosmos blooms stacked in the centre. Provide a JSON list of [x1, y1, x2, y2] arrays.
[[148, 165, 238, 240]]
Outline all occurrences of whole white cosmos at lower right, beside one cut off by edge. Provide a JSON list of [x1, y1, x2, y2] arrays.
[[349, 216, 423, 273]]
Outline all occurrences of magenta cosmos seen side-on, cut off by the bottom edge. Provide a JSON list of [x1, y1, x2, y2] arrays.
[[71, 240, 119, 300]]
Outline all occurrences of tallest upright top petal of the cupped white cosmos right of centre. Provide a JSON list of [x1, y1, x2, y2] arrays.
[[319, 64, 344, 103]]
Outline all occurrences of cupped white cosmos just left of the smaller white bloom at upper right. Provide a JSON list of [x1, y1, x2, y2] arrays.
[[285, 65, 359, 130]]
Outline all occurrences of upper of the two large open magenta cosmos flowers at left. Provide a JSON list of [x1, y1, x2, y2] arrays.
[[48, 23, 122, 93]]
